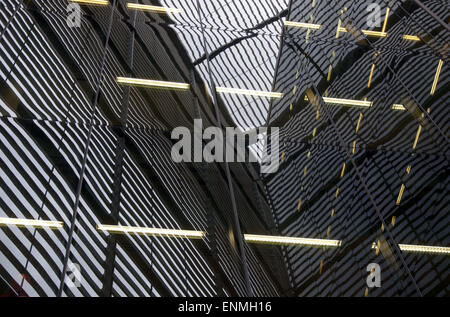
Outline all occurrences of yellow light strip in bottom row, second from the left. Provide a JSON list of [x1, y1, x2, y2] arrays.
[[97, 225, 205, 239]]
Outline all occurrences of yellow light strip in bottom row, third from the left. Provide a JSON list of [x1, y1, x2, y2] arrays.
[[244, 234, 342, 247]]
